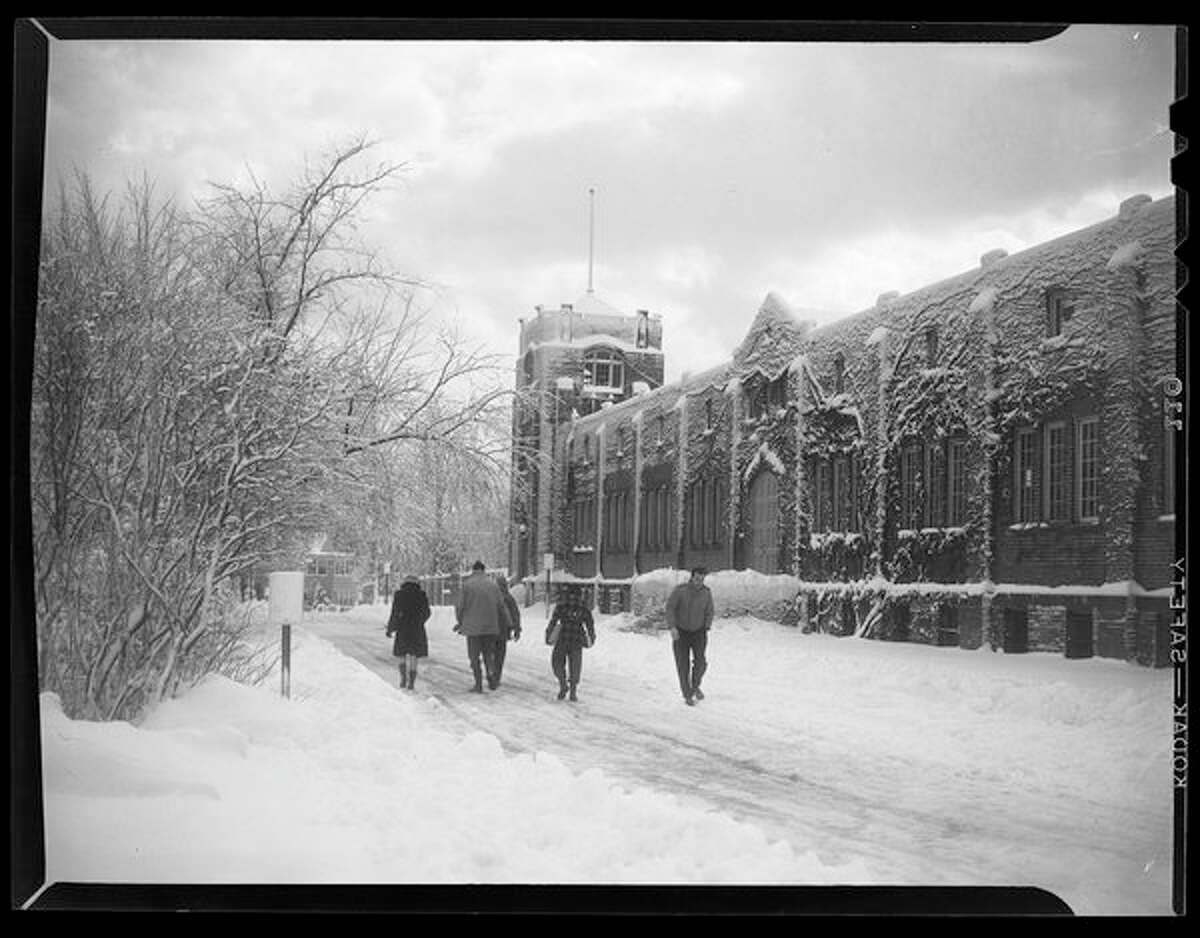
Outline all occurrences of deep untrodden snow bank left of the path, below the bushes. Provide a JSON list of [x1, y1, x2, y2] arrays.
[[41, 609, 864, 884]]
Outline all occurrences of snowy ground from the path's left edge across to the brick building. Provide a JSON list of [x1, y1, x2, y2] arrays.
[[305, 607, 1170, 914]]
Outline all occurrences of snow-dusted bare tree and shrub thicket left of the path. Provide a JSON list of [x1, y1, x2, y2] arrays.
[[31, 140, 516, 718]]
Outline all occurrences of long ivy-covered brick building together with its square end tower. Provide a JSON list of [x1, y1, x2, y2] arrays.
[[514, 196, 1182, 665]]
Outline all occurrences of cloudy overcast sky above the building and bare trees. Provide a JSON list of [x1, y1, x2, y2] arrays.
[[46, 25, 1175, 380]]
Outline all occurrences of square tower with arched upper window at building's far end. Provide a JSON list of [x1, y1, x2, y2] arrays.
[[509, 293, 662, 579]]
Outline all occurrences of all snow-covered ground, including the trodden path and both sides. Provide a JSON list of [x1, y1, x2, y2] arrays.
[[42, 606, 1171, 914]]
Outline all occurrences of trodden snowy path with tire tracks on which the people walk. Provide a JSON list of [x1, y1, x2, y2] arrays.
[[312, 614, 1160, 908]]
